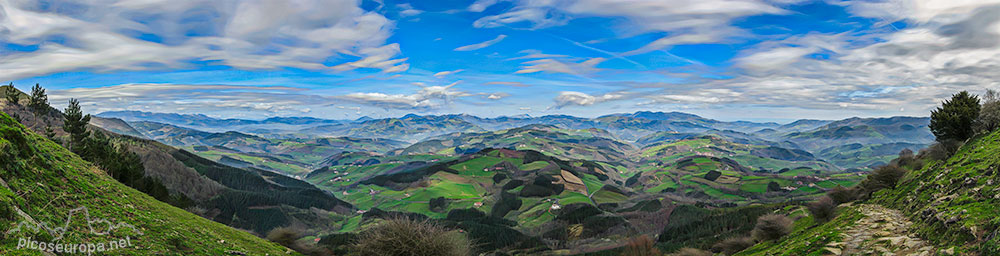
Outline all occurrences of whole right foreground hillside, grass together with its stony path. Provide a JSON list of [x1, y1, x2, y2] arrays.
[[738, 131, 1000, 255]]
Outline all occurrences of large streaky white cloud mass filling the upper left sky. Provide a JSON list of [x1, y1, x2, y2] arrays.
[[0, 0, 405, 80]]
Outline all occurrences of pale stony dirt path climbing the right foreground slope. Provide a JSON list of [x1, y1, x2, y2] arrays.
[[827, 204, 948, 256]]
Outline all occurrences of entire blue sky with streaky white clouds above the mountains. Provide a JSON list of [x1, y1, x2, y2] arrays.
[[0, 0, 1000, 121]]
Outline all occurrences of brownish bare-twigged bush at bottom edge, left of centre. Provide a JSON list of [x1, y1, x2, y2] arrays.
[[350, 218, 473, 256]]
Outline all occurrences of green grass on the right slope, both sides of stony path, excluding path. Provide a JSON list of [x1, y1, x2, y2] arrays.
[[739, 132, 1000, 255]]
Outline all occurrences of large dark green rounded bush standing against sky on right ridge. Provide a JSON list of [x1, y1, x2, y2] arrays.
[[928, 91, 980, 141]]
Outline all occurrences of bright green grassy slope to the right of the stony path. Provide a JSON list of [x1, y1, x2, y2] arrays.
[[873, 131, 1000, 255]]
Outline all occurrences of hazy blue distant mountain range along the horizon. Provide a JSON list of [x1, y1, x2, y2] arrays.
[[97, 111, 932, 144]]
